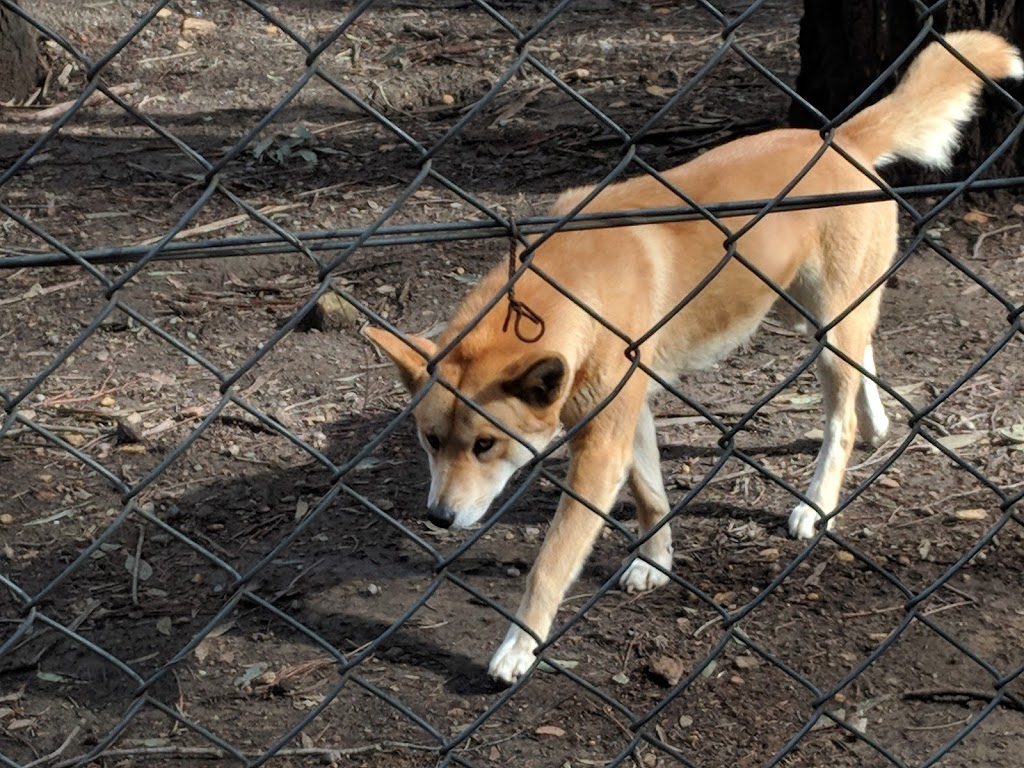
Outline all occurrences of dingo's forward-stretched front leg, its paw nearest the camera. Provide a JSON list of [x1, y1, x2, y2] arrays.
[[487, 434, 631, 683]]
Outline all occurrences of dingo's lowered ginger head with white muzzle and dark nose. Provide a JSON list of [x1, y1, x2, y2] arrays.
[[366, 328, 567, 528]]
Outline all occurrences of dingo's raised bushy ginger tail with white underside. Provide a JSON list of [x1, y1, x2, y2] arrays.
[[836, 31, 1024, 168]]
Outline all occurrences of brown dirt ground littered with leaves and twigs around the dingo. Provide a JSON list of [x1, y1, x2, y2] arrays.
[[0, 0, 1024, 768]]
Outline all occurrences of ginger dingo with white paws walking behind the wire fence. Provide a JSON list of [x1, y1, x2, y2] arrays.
[[366, 32, 1024, 683]]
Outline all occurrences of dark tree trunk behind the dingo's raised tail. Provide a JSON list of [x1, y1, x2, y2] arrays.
[[790, 0, 1024, 181]]
